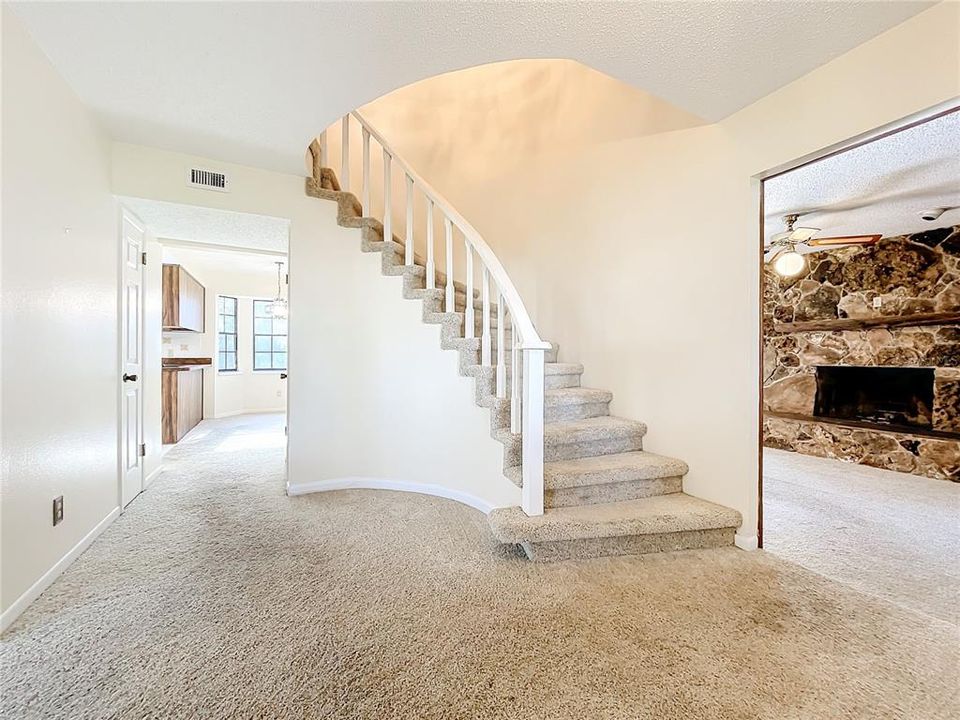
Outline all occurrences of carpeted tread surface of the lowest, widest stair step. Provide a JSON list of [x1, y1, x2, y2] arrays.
[[488, 493, 742, 543]]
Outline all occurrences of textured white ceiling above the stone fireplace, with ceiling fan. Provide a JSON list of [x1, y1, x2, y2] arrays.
[[764, 112, 960, 245]]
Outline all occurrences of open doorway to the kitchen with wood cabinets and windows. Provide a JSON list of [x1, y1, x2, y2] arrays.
[[121, 198, 289, 505]]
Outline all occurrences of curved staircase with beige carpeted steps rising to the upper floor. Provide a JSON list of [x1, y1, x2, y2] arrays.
[[306, 114, 742, 561]]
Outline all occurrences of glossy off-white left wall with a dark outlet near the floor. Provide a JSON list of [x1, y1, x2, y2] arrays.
[[0, 12, 119, 626]]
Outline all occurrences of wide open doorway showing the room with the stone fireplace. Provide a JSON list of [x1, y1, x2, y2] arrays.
[[759, 108, 960, 623]]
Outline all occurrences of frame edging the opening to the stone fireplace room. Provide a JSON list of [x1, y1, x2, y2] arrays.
[[751, 98, 960, 548]]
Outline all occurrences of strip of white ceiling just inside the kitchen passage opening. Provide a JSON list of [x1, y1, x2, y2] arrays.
[[121, 197, 290, 253]]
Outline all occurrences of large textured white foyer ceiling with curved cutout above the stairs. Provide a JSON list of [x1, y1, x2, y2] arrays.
[[14, 0, 934, 173]]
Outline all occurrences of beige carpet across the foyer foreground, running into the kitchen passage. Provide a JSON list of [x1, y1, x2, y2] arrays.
[[0, 416, 960, 720]]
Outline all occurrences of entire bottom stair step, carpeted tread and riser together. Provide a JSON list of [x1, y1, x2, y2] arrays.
[[488, 493, 742, 561]]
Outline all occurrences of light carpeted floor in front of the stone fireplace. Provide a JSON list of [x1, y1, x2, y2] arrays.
[[763, 449, 960, 625]]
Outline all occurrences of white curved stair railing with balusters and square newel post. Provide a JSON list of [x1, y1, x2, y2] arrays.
[[320, 112, 550, 515]]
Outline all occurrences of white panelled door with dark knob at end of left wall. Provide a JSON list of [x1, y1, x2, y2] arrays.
[[120, 213, 143, 507]]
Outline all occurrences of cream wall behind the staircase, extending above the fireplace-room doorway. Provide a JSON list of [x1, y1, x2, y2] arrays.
[[352, 3, 960, 546]]
